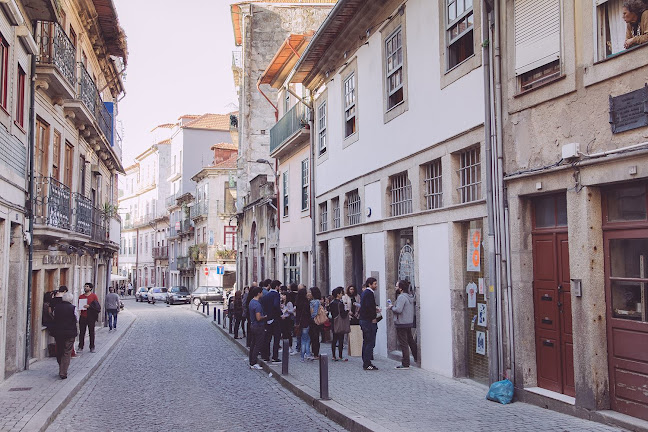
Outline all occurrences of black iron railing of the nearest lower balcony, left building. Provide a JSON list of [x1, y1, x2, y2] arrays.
[[33, 176, 72, 230]]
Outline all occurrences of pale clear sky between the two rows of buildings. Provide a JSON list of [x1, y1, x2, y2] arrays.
[[114, 0, 238, 166]]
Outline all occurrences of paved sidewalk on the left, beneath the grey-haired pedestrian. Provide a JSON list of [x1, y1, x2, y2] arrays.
[[0, 310, 135, 432]]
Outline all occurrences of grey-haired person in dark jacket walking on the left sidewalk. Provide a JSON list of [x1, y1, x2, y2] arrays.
[[53, 288, 78, 379]]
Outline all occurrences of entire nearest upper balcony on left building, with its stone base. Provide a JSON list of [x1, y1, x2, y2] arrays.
[[36, 21, 77, 100]]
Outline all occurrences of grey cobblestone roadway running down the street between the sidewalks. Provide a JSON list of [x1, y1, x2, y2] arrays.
[[48, 302, 344, 432]]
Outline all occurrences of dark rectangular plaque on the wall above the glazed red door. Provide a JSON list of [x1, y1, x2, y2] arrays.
[[610, 84, 648, 133]]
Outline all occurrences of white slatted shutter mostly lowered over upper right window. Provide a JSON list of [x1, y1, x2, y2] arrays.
[[515, 0, 560, 75]]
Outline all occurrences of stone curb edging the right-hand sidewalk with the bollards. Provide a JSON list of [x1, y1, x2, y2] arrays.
[[195, 310, 389, 432]]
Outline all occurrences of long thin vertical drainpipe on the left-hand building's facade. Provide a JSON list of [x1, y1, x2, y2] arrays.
[[25, 36, 36, 370]]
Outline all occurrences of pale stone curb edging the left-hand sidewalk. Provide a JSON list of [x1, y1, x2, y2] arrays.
[[23, 315, 137, 432]]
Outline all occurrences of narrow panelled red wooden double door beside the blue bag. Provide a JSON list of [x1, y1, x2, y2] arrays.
[[533, 232, 575, 396]]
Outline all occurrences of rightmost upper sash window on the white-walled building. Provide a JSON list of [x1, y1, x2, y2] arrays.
[[446, 0, 474, 70]]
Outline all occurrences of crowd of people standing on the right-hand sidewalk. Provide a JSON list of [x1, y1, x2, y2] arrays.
[[227, 278, 417, 370]]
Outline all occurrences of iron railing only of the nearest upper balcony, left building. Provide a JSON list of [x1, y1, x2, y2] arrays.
[[37, 21, 76, 87]]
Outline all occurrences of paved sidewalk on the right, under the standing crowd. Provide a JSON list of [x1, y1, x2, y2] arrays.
[[201, 308, 624, 432]]
